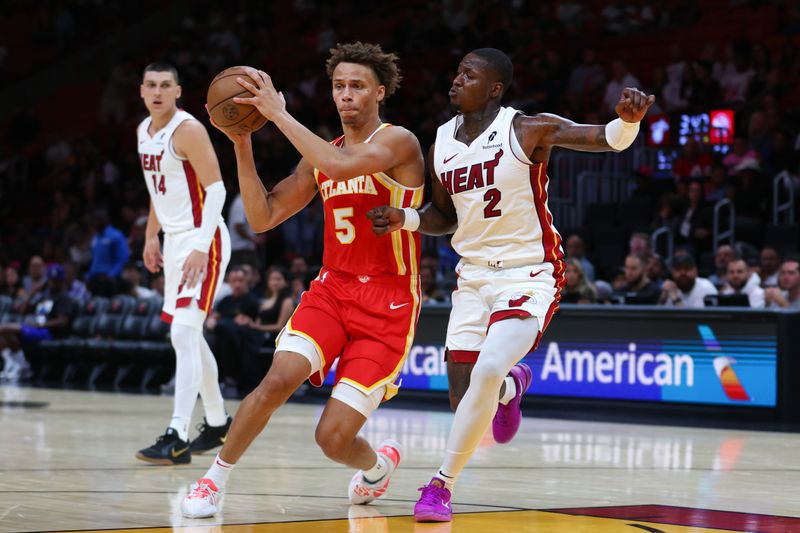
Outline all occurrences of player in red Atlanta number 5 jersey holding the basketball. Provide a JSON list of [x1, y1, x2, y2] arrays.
[[182, 43, 424, 518]]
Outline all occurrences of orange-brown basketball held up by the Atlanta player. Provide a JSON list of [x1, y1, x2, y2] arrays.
[[206, 67, 267, 133]]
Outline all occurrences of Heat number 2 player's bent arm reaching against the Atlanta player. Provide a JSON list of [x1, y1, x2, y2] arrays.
[[367, 145, 458, 235]]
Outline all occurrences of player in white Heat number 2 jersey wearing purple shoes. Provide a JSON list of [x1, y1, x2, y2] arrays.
[[368, 48, 655, 522]]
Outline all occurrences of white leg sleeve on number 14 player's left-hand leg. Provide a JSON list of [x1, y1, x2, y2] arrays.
[[169, 318, 203, 441]]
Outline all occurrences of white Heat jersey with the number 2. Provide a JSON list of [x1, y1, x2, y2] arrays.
[[433, 107, 564, 266]]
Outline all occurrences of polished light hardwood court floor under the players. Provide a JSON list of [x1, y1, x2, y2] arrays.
[[0, 387, 800, 533]]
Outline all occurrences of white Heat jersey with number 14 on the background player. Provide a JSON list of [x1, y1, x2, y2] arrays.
[[136, 110, 222, 233]]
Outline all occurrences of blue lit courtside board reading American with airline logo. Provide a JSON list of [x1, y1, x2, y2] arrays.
[[326, 313, 778, 407]]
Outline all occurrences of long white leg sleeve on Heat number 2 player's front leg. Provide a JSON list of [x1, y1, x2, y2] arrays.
[[441, 317, 539, 483]]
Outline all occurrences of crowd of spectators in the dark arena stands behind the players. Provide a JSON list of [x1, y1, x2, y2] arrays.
[[0, 0, 800, 388]]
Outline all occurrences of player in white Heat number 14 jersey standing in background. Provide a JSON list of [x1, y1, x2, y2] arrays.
[[136, 63, 231, 464]]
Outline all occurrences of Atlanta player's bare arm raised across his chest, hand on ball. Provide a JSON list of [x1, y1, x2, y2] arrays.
[[233, 70, 422, 180]]
